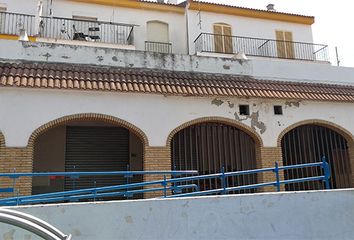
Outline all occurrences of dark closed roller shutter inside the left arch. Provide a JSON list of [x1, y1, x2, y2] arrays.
[[65, 127, 129, 190]]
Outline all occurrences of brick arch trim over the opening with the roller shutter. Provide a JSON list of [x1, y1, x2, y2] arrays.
[[27, 113, 149, 147]]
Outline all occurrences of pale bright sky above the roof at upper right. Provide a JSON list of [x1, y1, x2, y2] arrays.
[[177, 0, 354, 67]]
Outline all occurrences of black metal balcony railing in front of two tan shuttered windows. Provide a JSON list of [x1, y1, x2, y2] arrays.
[[194, 33, 329, 61]]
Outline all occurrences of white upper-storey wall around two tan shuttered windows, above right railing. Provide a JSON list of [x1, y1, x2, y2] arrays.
[[188, 10, 313, 54]]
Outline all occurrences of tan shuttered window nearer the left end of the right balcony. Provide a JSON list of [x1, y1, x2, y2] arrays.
[[213, 23, 233, 53]]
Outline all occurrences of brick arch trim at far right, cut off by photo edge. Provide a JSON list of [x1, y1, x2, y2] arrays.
[[277, 119, 354, 147]]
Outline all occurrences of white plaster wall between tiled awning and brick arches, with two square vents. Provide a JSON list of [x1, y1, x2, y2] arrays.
[[0, 88, 354, 147]]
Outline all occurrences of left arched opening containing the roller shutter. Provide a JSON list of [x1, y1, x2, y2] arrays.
[[32, 116, 146, 197]]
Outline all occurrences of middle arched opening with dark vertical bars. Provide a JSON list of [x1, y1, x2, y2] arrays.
[[171, 122, 257, 193]]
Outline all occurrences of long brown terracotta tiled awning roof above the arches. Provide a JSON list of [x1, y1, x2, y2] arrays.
[[0, 63, 354, 102]]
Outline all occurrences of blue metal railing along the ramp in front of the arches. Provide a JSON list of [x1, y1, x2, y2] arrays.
[[0, 157, 330, 206]]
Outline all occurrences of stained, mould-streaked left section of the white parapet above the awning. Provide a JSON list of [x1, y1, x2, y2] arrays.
[[0, 40, 251, 75]]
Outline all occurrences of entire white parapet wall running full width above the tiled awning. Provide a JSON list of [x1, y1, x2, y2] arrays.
[[0, 39, 354, 84]]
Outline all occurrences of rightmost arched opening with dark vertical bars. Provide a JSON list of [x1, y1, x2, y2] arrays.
[[281, 124, 351, 191]]
